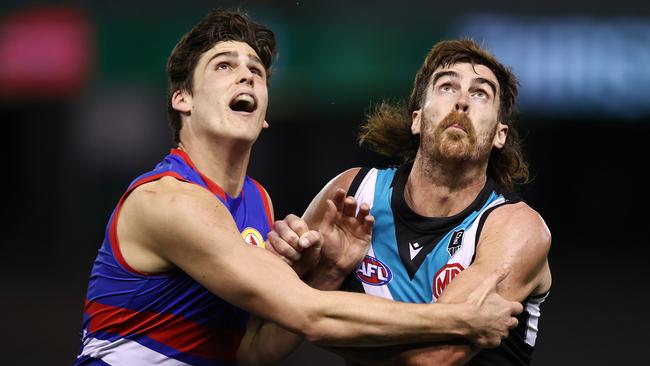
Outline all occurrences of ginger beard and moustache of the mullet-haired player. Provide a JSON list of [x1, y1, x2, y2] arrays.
[[420, 111, 496, 162]]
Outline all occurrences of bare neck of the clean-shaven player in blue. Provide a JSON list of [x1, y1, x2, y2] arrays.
[[179, 139, 251, 197]]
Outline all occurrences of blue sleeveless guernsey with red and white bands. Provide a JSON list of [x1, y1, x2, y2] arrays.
[[75, 149, 272, 366]]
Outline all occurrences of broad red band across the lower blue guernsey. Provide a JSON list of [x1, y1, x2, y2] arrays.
[[84, 301, 243, 361]]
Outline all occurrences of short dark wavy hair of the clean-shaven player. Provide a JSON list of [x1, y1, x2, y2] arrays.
[[167, 9, 277, 143]]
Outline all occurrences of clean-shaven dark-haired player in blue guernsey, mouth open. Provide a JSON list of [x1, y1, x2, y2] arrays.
[[75, 11, 522, 365]]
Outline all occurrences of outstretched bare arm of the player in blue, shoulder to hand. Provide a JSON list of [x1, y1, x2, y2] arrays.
[[118, 178, 522, 352]]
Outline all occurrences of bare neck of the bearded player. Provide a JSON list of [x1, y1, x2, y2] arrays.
[[404, 154, 487, 217]]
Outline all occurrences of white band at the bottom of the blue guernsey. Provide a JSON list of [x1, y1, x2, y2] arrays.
[[77, 338, 190, 366]]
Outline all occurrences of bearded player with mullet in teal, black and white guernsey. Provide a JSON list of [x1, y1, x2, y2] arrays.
[[271, 39, 551, 365]]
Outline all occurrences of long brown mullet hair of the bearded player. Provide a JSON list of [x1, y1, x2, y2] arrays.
[[359, 39, 529, 189]]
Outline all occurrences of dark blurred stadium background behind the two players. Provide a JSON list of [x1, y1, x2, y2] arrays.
[[0, 0, 650, 365]]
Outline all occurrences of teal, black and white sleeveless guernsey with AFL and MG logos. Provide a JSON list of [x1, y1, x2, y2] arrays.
[[343, 165, 547, 365]]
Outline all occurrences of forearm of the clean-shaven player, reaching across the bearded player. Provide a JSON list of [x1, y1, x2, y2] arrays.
[[238, 284, 476, 346]]
